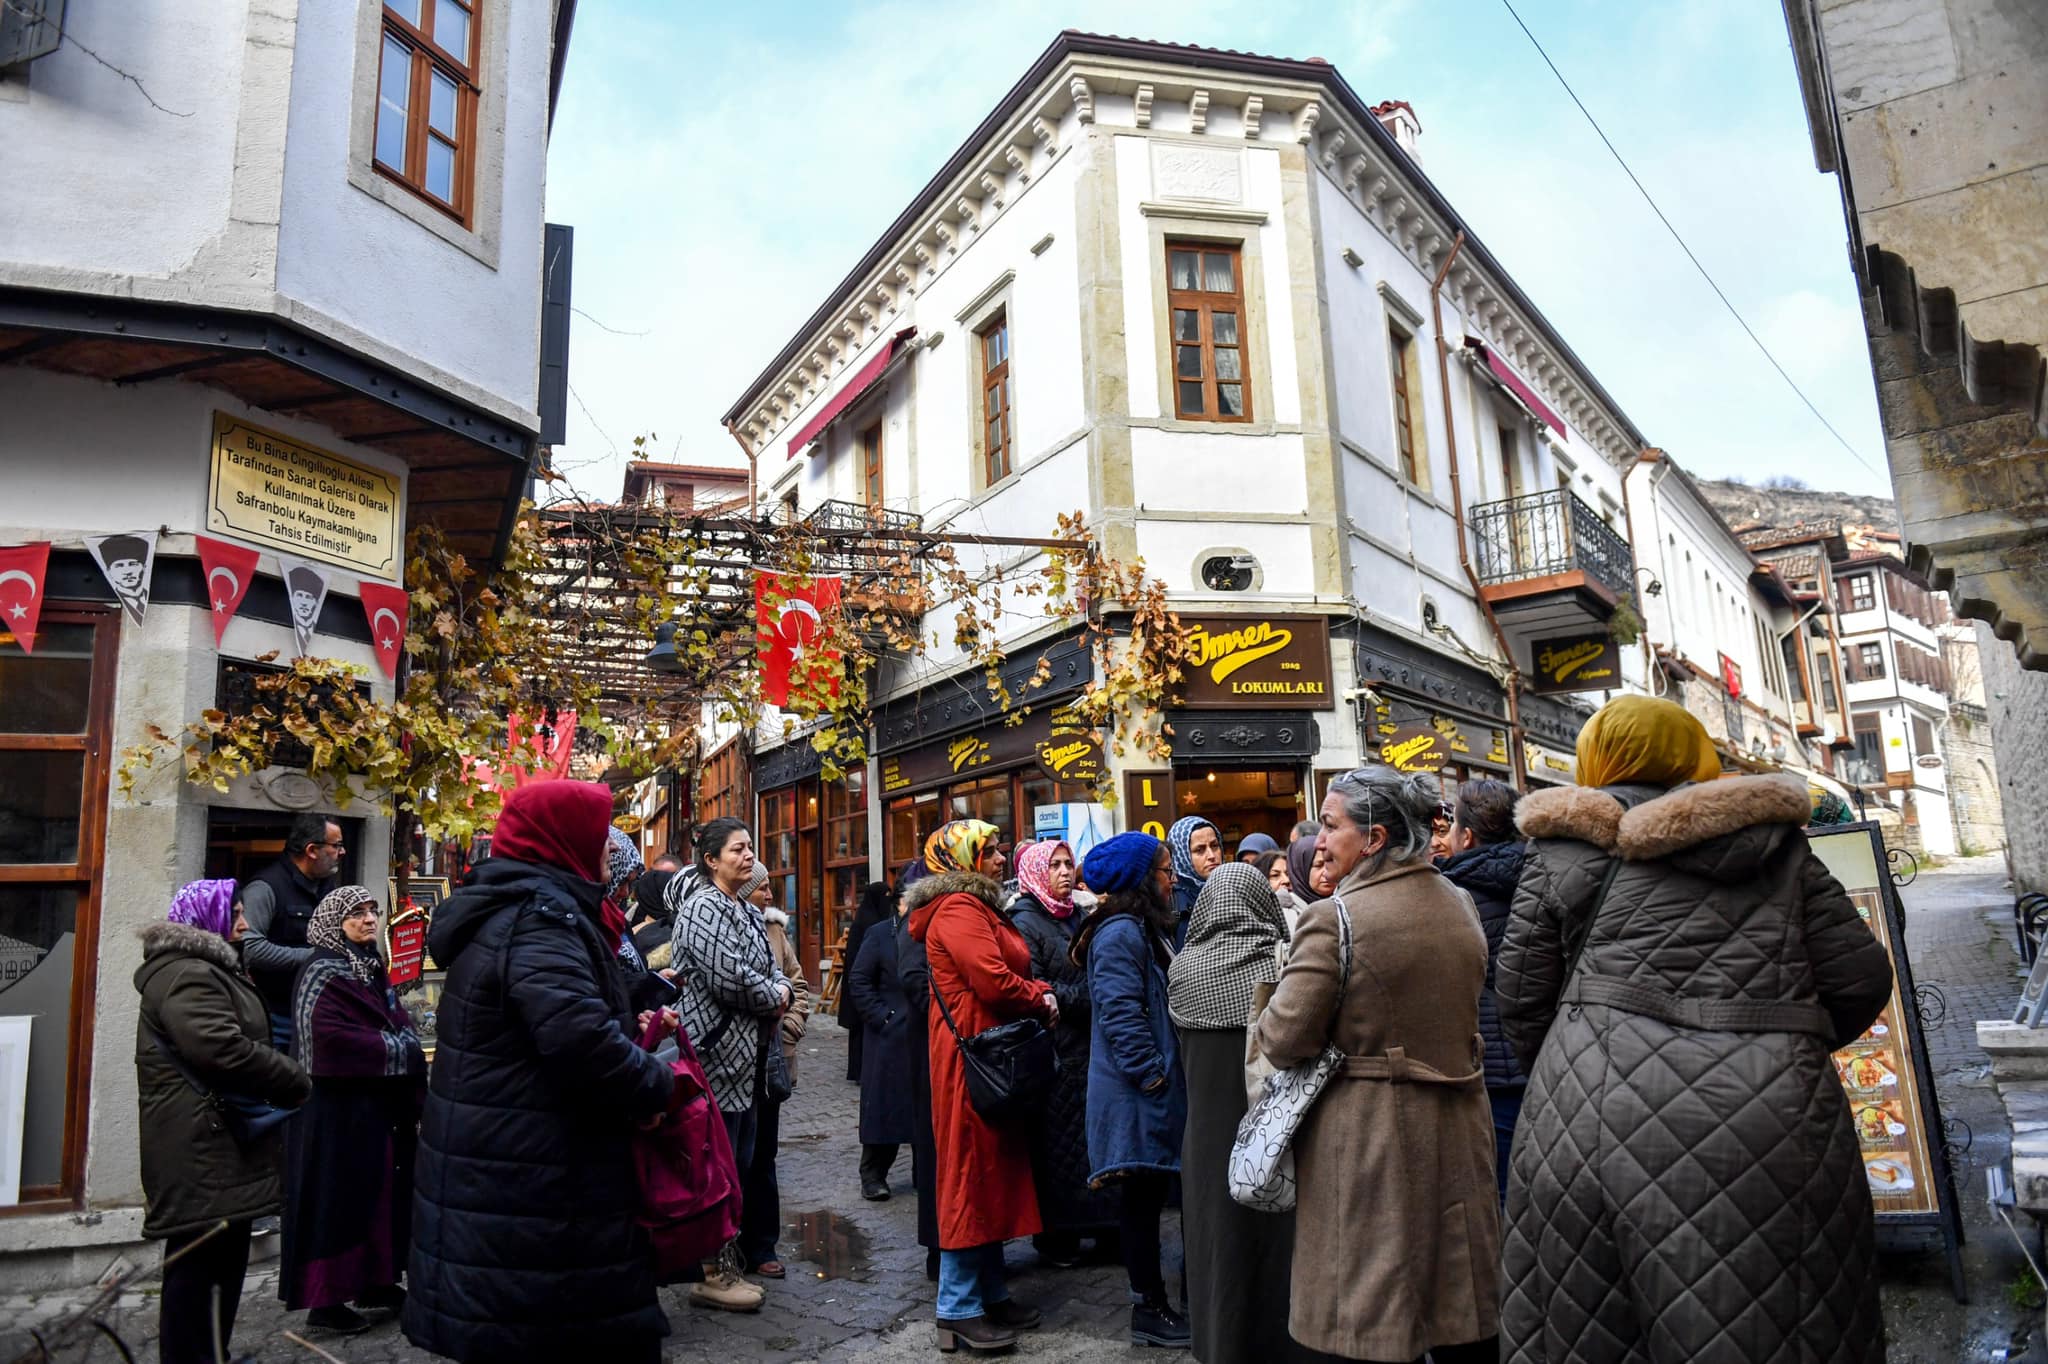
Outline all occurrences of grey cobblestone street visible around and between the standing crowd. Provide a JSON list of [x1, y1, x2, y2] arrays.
[[0, 858, 2044, 1364]]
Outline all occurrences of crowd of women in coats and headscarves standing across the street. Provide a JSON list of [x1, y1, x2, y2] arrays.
[[137, 698, 1890, 1364]]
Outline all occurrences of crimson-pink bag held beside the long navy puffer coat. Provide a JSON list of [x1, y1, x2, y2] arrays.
[[633, 1026, 739, 1284]]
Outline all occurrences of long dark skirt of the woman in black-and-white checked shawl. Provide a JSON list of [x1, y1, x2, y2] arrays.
[[1180, 1028, 1323, 1364]]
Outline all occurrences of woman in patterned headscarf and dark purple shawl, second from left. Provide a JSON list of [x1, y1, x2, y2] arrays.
[[279, 885, 426, 1333]]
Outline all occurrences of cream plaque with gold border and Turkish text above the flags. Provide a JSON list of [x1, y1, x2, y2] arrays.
[[207, 412, 406, 582]]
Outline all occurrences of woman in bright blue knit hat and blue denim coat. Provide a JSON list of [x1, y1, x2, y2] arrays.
[[1073, 834, 1188, 1350]]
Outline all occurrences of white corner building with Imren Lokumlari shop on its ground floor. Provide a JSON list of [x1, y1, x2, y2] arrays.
[[707, 33, 1645, 913]]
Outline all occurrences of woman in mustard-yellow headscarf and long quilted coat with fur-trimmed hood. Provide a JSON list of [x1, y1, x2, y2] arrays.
[[1497, 696, 1892, 1364]]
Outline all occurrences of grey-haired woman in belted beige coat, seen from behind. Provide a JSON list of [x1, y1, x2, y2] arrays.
[[1257, 766, 1501, 1364]]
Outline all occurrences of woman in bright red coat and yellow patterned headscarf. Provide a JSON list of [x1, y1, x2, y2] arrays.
[[903, 819, 1059, 1352]]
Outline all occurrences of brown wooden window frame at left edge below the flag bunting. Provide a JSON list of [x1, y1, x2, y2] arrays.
[[0, 602, 121, 1219]]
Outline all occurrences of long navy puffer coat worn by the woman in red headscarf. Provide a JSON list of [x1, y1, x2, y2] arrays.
[[406, 858, 674, 1364]]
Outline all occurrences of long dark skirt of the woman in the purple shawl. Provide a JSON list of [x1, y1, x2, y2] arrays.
[[279, 1077, 420, 1311]]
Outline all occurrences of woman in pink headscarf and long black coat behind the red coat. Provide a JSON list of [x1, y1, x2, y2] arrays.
[[1010, 840, 1116, 1268]]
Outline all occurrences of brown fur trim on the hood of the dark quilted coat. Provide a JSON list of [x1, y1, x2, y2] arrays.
[[1516, 774, 1812, 881]]
